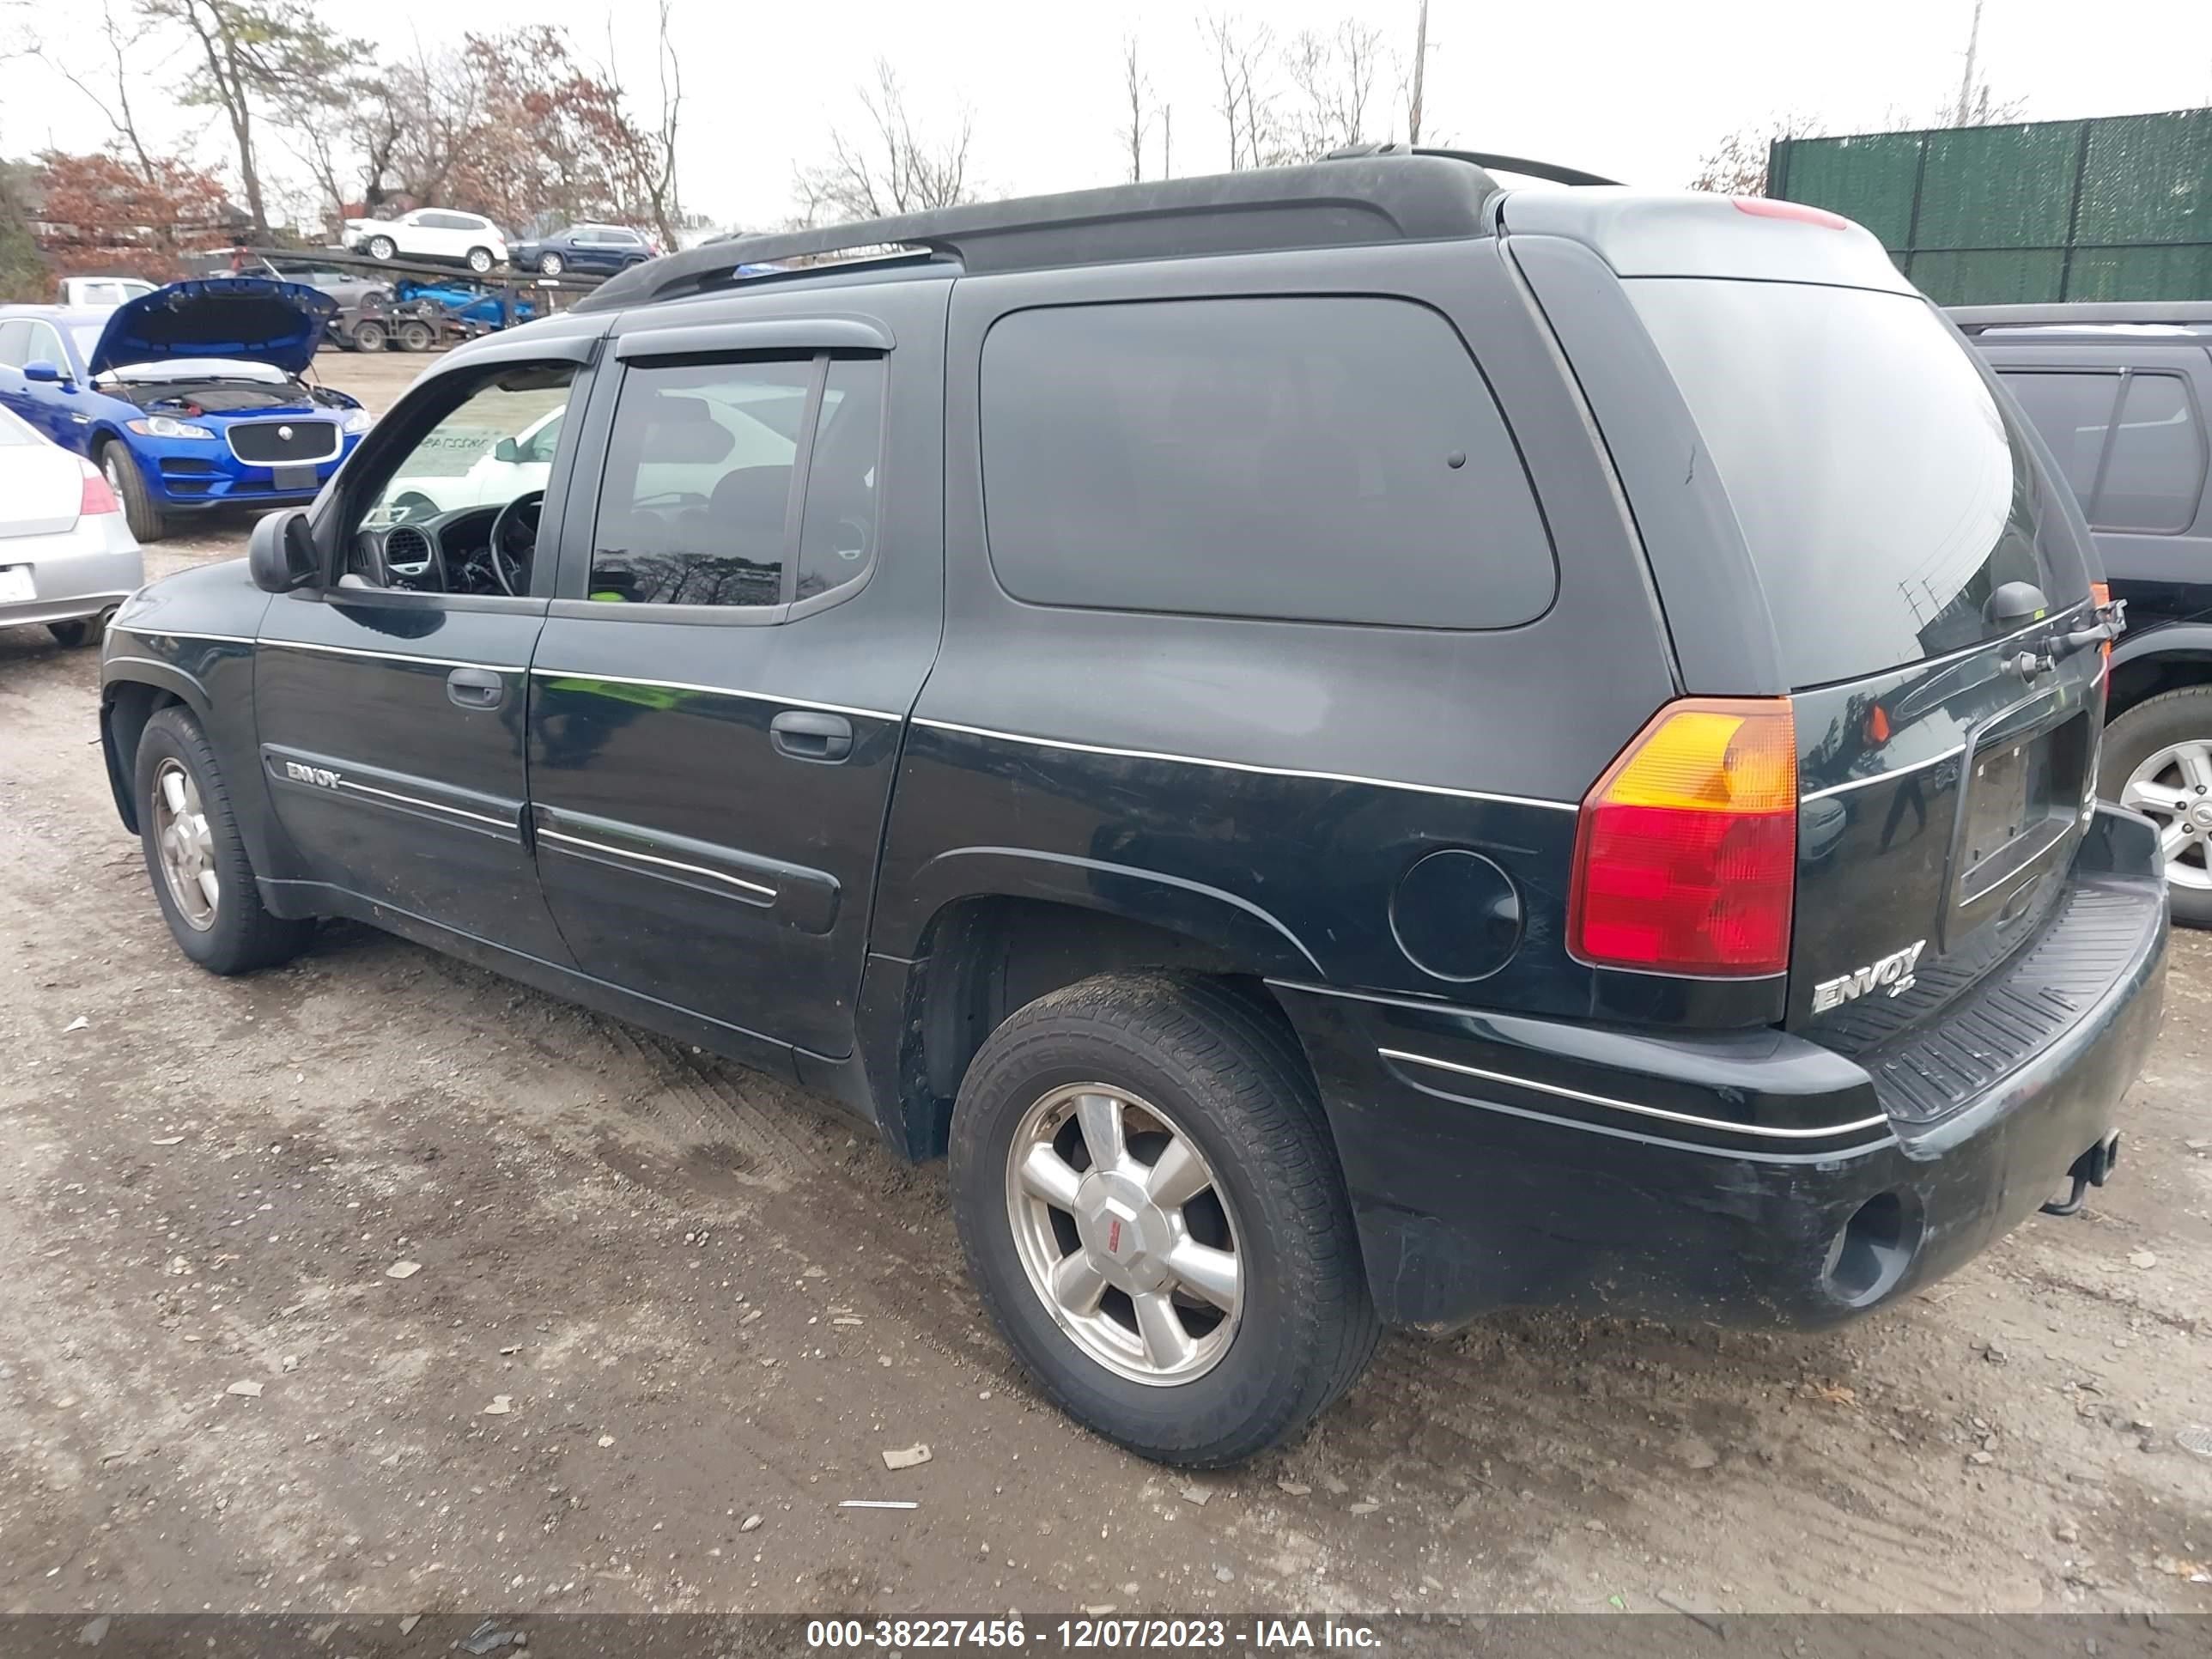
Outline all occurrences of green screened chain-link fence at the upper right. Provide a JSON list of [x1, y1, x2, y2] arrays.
[[1767, 108, 2212, 305]]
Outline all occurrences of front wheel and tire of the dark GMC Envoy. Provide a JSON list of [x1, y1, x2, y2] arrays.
[[135, 706, 314, 973]]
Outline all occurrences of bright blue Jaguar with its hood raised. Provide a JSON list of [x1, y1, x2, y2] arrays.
[[0, 276, 369, 542]]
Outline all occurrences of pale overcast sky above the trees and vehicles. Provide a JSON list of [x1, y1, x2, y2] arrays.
[[0, 0, 2212, 226]]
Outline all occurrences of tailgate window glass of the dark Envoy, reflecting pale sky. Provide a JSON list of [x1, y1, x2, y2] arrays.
[[1626, 276, 2088, 686]]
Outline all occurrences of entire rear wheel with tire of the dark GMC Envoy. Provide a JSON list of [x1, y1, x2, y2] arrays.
[[951, 975, 1380, 1468]]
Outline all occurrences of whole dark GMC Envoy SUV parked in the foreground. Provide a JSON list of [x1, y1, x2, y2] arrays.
[[104, 153, 2166, 1464]]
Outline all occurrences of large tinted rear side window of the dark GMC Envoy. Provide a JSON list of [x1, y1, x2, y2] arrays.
[[982, 296, 1555, 629]]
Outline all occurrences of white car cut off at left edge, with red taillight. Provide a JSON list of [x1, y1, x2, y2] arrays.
[[0, 410, 146, 646]]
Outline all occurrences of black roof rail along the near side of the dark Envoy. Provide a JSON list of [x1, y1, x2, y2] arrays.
[[573, 153, 1504, 312]]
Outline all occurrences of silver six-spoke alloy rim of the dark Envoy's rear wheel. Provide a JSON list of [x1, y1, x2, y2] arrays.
[[1006, 1084, 1245, 1385]]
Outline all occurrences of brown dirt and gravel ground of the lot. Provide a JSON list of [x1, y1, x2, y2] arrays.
[[0, 356, 2212, 1646]]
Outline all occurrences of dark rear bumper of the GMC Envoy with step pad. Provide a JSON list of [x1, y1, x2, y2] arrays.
[[1274, 810, 2166, 1328]]
